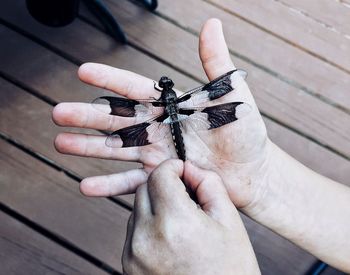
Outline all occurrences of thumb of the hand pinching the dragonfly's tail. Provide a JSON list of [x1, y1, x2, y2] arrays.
[[183, 161, 238, 225]]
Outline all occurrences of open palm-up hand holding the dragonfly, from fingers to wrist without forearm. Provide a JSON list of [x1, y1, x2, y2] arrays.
[[53, 19, 270, 207]]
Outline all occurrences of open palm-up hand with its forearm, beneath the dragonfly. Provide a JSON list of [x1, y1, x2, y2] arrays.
[[53, 19, 350, 272]]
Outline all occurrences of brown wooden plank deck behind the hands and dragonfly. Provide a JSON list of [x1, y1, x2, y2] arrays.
[[0, 0, 350, 275]]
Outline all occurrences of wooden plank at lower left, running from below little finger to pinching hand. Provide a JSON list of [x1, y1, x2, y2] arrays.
[[0, 137, 129, 271]]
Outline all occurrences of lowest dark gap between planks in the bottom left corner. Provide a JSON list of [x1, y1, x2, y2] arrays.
[[0, 202, 122, 275]]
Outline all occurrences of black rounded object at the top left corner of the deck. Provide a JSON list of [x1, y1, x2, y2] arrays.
[[26, 0, 80, 27]]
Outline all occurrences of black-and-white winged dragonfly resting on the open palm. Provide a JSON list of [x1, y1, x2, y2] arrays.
[[92, 69, 251, 161]]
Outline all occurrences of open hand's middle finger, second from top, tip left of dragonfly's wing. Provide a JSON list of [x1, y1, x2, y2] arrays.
[[52, 102, 137, 131]]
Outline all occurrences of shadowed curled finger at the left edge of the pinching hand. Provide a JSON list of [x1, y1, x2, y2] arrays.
[[134, 184, 152, 222]]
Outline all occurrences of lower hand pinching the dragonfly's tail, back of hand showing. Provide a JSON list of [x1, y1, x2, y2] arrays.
[[123, 160, 260, 275]]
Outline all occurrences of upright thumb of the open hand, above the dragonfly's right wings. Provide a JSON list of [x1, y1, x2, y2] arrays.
[[199, 18, 235, 80]]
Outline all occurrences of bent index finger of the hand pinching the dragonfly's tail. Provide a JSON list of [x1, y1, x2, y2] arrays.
[[147, 159, 194, 214]]
